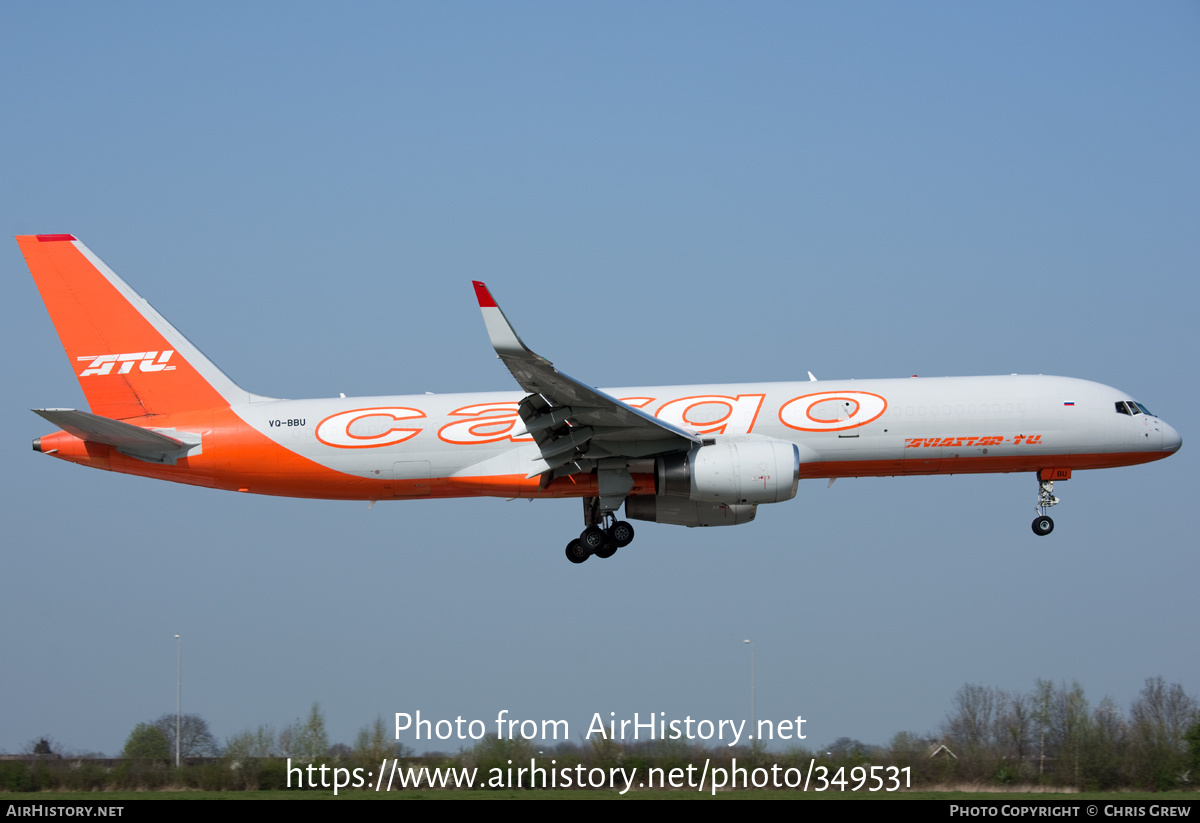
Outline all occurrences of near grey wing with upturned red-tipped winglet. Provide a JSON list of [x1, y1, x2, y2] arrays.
[[474, 281, 701, 485]]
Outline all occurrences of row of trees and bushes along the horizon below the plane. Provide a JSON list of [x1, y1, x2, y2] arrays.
[[0, 678, 1200, 791]]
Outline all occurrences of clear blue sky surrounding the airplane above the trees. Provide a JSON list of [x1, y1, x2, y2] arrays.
[[0, 2, 1200, 752]]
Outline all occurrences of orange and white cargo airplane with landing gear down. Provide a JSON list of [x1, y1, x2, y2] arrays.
[[17, 234, 1182, 563]]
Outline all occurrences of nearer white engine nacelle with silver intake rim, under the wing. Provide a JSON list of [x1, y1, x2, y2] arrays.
[[654, 437, 800, 505]]
